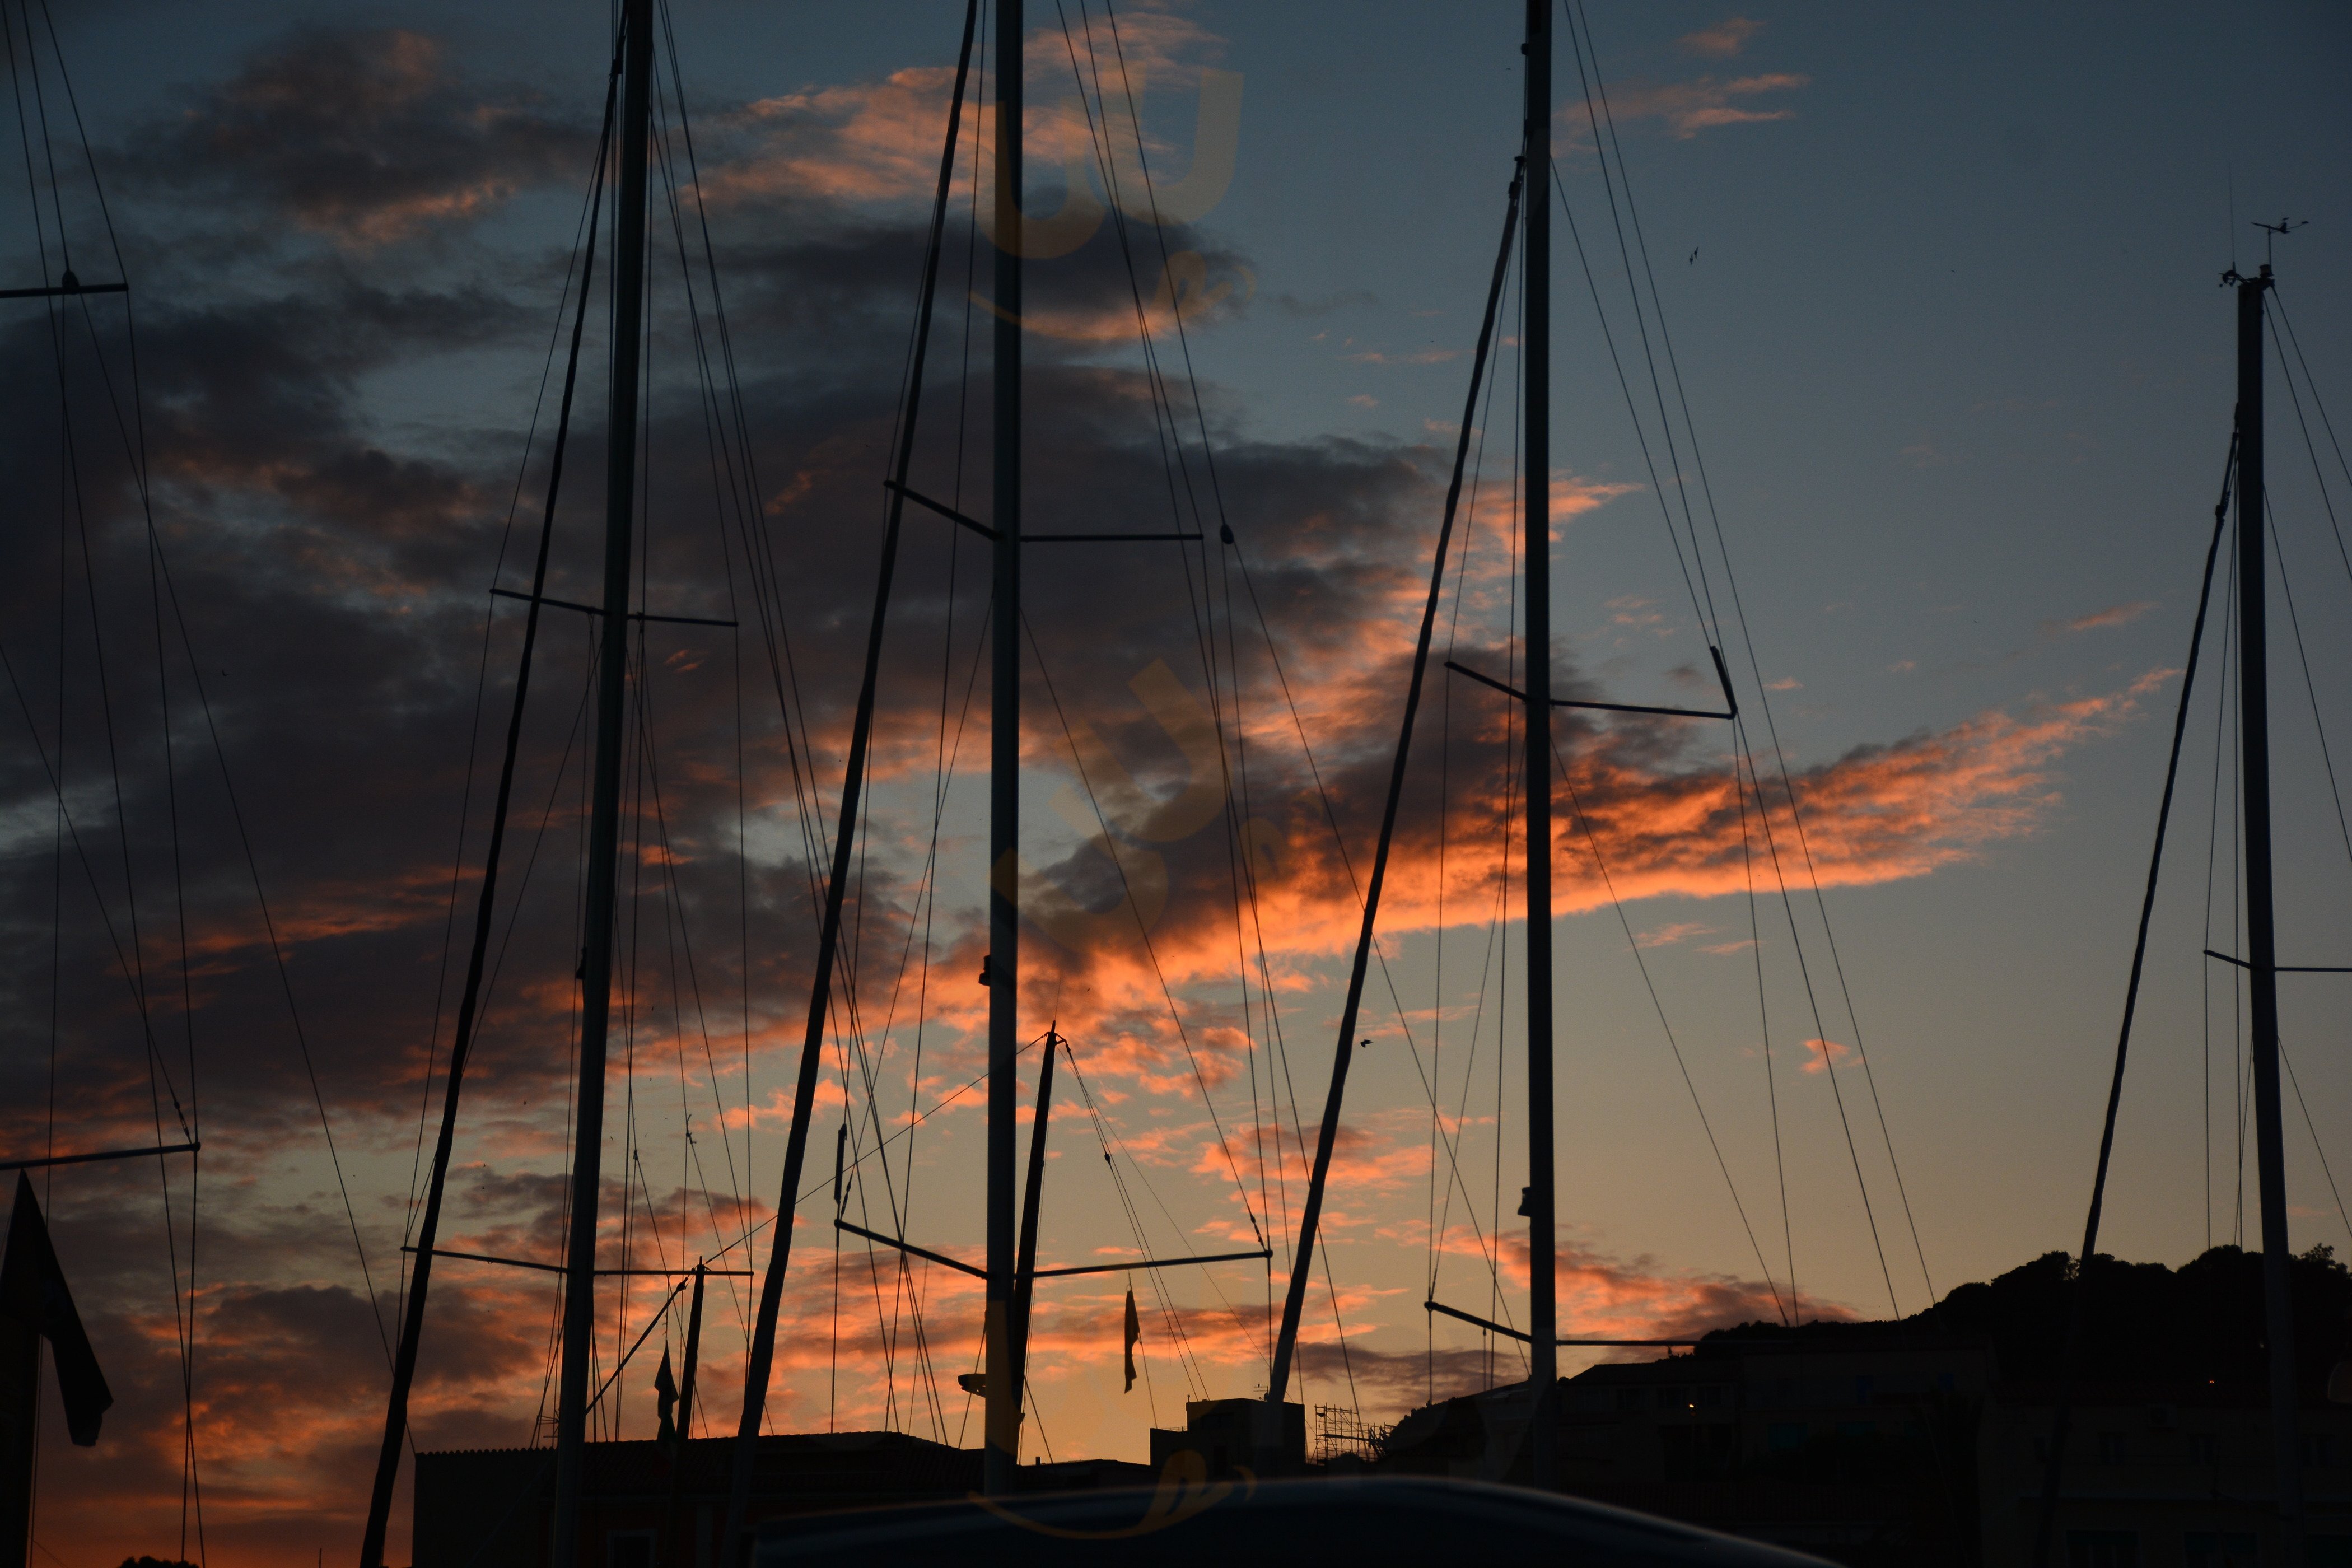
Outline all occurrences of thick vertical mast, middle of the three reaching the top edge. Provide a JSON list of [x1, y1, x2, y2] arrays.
[[981, 0, 1021, 1497]]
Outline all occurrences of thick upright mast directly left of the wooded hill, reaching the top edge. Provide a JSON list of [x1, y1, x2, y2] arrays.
[[1519, 0, 1560, 1488]]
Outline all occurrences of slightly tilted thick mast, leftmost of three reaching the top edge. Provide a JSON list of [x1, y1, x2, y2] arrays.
[[550, 0, 654, 1568]]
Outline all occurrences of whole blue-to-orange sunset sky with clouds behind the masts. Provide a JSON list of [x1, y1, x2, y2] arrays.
[[0, 0, 2352, 1568]]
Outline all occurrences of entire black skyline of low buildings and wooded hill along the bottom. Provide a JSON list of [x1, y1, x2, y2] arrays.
[[414, 1248, 2352, 1568]]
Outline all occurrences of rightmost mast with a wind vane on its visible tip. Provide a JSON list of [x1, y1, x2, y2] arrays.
[[2237, 263, 2303, 1561]]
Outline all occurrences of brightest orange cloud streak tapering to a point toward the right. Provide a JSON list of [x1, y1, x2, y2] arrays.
[[908, 648, 2164, 1151]]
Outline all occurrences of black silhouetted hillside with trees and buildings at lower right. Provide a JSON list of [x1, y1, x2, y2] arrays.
[[1380, 1246, 2352, 1568]]
